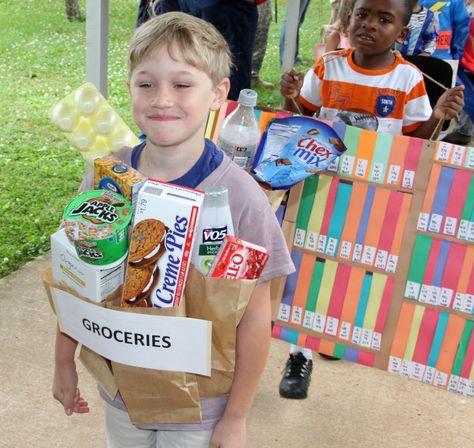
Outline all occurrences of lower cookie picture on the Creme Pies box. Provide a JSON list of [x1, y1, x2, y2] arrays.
[[121, 265, 160, 308]]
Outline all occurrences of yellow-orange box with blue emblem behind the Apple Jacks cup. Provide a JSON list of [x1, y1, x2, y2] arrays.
[[94, 155, 146, 209]]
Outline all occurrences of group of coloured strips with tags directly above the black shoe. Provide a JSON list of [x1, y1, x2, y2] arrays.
[[278, 251, 394, 350]]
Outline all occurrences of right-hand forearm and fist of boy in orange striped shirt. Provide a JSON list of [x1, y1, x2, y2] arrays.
[[409, 86, 464, 139]]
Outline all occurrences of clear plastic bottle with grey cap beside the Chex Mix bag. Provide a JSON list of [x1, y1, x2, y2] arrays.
[[217, 89, 260, 170]]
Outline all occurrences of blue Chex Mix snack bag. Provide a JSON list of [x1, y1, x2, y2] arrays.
[[253, 117, 346, 190]]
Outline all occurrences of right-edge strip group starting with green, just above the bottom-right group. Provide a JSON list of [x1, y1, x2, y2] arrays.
[[404, 234, 474, 314]]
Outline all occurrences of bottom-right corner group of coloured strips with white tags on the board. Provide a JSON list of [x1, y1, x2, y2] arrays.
[[388, 302, 474, 395]]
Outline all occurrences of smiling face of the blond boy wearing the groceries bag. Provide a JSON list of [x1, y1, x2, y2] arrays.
[[128, 48, 229, 147]]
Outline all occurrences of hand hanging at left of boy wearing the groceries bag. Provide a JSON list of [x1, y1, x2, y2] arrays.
[[53, 362, 89, 416]]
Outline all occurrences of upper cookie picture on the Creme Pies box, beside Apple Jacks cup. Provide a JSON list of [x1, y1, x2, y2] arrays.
[[128, 219, 168, 267]]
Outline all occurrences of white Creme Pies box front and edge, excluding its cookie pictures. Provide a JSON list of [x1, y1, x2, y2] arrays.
[[132, 179, 204, 308]]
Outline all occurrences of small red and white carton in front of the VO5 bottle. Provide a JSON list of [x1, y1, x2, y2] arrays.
[[209, 235, 269, 280]]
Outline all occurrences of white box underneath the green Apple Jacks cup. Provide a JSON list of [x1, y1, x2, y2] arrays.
[[51, 229, 125, 302]]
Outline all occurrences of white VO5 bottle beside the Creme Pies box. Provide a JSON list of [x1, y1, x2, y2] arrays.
[[191, 187, 234, 275]]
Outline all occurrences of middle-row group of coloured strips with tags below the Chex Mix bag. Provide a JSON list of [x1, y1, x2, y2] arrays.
[[293, 174, 412, 273]]
